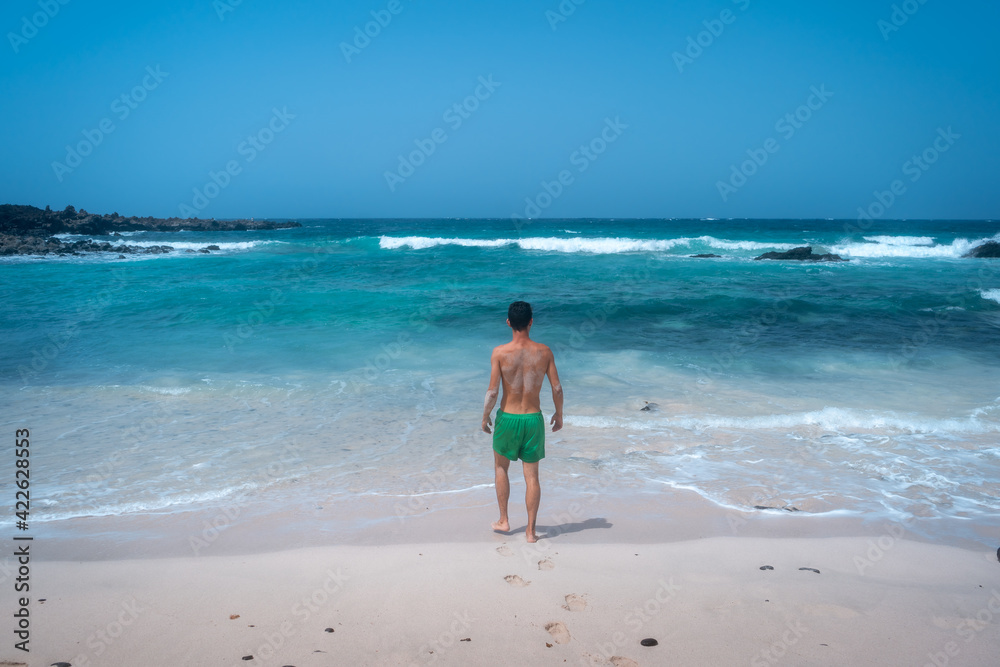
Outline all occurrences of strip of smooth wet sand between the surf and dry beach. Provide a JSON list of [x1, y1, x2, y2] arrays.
[[25, 483, 998, 562]]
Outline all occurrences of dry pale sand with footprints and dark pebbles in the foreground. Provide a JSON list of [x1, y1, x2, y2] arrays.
[[21, 533, 1000, 667]]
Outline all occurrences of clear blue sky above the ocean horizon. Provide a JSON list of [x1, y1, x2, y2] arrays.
[[0, 0, 1000, 219]]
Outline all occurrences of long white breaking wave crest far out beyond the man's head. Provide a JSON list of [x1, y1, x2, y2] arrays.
[[379, 236, 795, 254]]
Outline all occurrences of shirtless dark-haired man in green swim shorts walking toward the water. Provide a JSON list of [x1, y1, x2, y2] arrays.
[[483, 301, 563, 542]]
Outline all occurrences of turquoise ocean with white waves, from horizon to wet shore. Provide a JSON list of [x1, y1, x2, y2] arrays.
[[0, 220, 1000, 539]]
